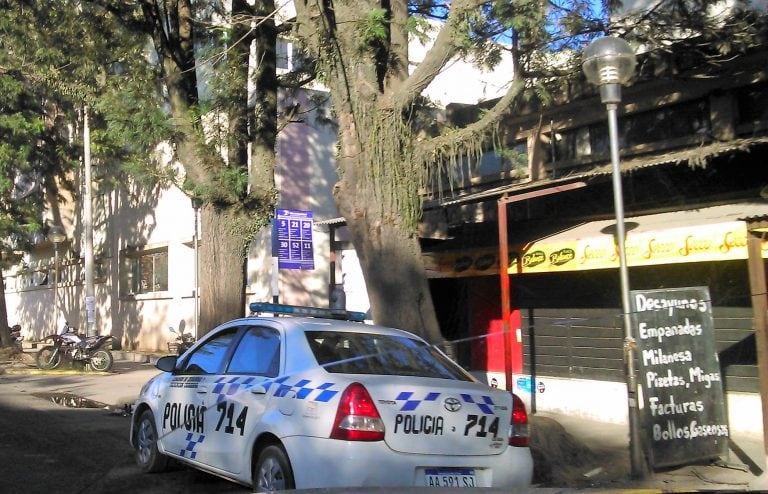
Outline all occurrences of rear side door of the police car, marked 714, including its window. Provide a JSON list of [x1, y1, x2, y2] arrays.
[[206, 325, 283, 474]]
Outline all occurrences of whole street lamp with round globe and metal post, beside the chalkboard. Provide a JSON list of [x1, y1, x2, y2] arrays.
[[582, 36, 646, 477]]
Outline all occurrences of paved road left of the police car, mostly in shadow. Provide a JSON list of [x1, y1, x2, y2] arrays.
[[0, 363, 251, 494]]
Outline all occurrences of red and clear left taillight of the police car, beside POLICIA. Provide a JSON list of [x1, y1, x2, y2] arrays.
[[331, 383, 384, 441]]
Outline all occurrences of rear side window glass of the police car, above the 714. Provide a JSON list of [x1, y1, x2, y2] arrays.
[[227, 326, 280, 377]]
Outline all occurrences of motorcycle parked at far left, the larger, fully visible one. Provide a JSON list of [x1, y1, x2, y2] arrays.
[[36, 323, 114, 372]]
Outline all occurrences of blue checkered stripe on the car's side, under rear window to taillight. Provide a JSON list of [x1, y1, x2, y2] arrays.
[[212, 376, 339, 403]]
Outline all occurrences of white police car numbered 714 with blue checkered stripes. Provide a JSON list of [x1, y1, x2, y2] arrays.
[[130, 304, 533, 491]]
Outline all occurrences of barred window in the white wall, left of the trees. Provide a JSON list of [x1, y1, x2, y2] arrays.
[[121, 247, 168, 295]]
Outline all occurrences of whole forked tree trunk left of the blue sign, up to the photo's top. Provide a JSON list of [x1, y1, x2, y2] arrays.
[[142, 0, 277, 336]]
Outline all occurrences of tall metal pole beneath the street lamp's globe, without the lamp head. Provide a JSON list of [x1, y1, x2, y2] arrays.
[[605, 103, 646, 477]]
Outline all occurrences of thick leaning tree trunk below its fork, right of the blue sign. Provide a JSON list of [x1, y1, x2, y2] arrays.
[[334, 105, 443, 343]]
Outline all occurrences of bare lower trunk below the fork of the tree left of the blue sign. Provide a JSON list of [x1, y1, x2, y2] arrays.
[[197, 204, 250, 336]]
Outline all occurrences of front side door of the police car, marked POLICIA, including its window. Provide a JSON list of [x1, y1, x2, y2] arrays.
[[158, 328, 237, 465]]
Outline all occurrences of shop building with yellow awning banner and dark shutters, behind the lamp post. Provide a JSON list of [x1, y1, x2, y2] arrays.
[[423, 44, 768, 450]]
